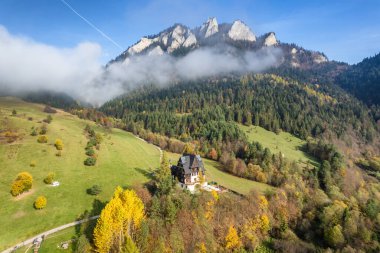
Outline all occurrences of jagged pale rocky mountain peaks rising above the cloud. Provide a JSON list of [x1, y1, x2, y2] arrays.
[[111, 18, 329, 71]]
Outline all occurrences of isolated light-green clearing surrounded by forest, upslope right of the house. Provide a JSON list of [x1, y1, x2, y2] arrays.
[[239, 125, 318, 168]]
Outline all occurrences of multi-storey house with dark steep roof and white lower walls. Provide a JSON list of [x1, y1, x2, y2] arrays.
[[171, 154, 207, 191]]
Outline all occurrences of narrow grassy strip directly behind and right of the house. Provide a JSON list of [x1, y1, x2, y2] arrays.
[[168, 153, 273, 194]]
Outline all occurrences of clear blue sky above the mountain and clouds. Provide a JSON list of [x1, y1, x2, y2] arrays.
[[0, 0, 380, 63]]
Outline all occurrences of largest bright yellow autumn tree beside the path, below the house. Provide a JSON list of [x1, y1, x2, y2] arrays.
[[94, 187, 145, 253]]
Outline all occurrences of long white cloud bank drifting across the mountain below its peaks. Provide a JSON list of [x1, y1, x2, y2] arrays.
[[0, 26, 281, 105]]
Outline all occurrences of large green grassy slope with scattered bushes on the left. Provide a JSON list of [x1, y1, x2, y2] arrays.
[[0, 98, 160, 250]]
